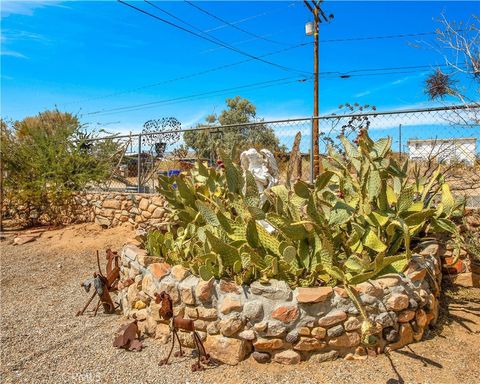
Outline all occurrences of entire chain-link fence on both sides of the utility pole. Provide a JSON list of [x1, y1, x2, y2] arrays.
[[87, 106, 480, 207]]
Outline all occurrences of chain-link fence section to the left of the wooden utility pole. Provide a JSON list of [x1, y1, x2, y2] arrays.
[[90, 118, 312, 193]]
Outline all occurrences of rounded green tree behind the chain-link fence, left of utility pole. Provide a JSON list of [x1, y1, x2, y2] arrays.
[[183, 96, 284, 158]]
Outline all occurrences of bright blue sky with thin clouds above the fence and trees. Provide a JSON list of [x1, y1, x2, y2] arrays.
[[1, 1, 479, 139]]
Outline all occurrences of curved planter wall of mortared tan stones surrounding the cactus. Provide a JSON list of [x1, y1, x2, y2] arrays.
[[119, 243, 441, 364]]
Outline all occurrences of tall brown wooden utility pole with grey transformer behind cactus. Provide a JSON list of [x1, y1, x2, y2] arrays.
[[303, 0, 333, 181]]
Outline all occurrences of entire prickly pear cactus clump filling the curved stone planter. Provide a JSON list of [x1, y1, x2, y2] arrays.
[[151, 130, 459, 287]]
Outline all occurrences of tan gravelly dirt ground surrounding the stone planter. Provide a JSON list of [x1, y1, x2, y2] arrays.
[[0, 224, 480, 384]]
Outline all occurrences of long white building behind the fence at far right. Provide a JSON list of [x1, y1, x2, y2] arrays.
[[407, 137, 477, 165]]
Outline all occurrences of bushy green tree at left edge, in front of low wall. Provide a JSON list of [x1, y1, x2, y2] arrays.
[[0, 111, 118, 224]]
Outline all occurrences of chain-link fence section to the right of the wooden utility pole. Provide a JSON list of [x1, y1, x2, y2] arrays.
[[319, 105, 480, 207]]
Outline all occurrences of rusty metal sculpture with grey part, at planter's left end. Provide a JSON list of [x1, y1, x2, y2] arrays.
[[77, 249, 120, 316]]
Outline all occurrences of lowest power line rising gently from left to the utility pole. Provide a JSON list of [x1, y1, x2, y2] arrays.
[[83, 77, 308, 115]]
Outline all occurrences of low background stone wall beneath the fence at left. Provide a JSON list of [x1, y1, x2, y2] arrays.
[[4, 192, 167, 228]]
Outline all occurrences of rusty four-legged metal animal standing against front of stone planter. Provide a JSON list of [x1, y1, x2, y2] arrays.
[[154, 291, 211, 372]]
